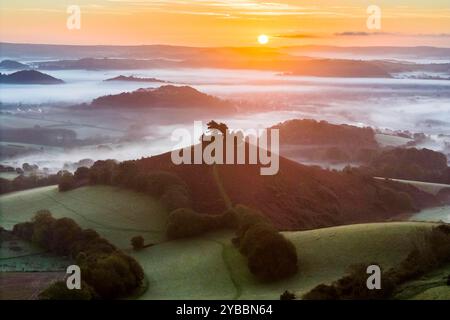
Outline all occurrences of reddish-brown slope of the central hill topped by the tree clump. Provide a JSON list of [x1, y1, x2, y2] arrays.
[[134, 148, 438, 230]]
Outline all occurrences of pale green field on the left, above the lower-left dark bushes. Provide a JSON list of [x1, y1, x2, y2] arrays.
[[0, 186, 167, 248]]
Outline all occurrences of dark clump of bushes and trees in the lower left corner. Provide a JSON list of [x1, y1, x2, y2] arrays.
[[13, 210, 144, 299]]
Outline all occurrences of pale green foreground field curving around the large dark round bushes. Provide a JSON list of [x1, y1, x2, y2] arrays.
[[131, 222, 431, 299]]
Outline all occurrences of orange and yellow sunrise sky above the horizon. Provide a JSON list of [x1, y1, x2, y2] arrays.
[[0, 0, 450, 47]]
